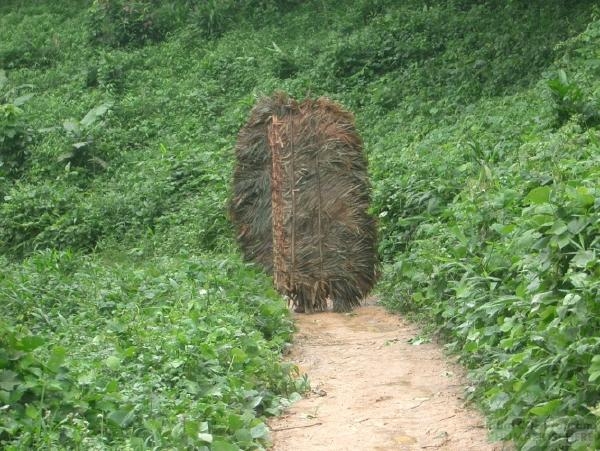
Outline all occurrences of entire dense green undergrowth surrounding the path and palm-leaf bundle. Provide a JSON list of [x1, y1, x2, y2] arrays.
[[0, 0, 600, 450]]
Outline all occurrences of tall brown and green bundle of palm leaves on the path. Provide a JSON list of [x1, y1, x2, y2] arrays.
[[231, 94, 377, 312]]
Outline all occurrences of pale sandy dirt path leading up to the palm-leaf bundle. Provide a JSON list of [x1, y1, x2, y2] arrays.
[[270, 305, 508, 451]]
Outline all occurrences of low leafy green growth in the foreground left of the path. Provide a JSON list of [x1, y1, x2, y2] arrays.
[[0, 251, 305, 450]]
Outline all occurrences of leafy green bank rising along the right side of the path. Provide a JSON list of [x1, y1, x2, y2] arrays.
[[372, 5, 600, 450]]
